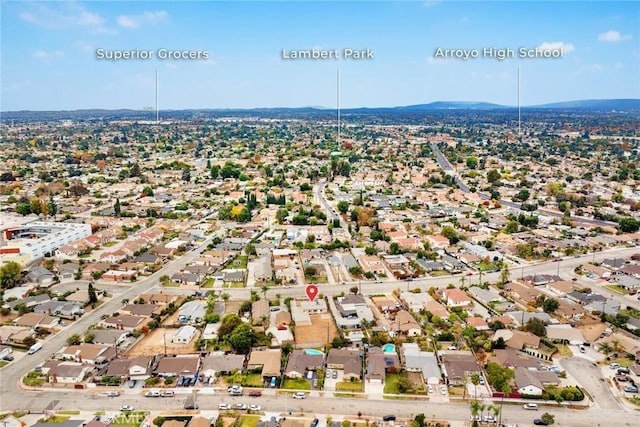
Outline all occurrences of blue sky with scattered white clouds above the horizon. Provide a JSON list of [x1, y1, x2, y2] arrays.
[[0, 0, 640, 111]]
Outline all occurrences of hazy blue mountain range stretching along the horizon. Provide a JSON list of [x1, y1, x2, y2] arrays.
[[0, 99, 640, 120]]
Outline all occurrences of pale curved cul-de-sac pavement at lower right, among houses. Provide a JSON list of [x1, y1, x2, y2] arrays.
[[560, 356, 621, 410]]
